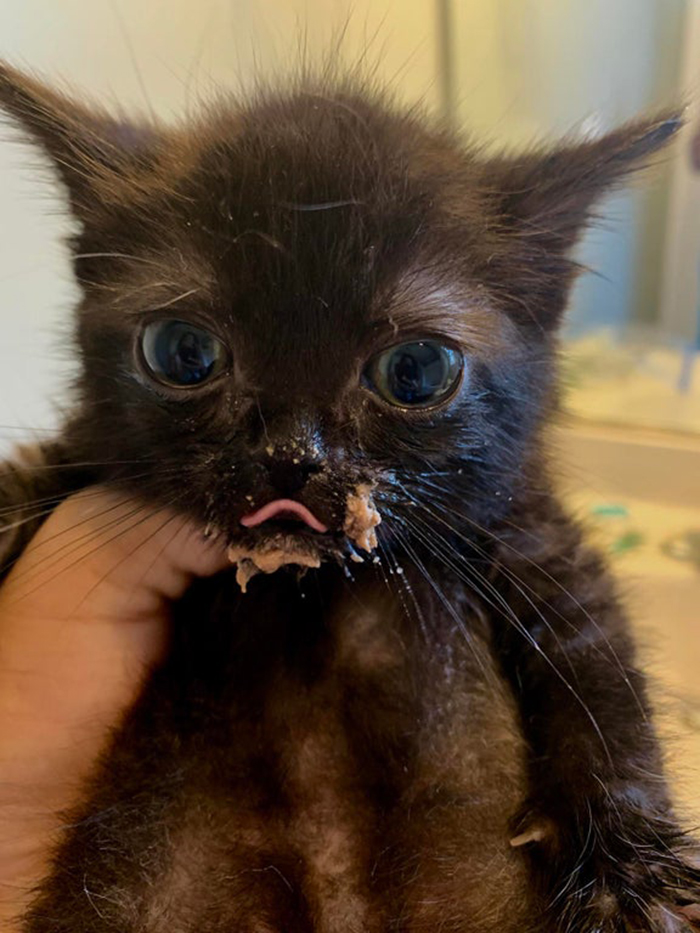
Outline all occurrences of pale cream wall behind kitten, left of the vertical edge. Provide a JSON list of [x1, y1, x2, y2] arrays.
[[0, 0, 438, 444]]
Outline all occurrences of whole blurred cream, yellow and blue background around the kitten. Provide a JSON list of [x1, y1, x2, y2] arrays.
[[0, 0, 700, 817]]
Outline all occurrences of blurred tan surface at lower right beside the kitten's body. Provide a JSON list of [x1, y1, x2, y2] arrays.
[[555, 423, 700, 825]]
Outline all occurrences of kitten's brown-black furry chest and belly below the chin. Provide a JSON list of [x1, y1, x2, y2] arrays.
[[64, 572, 531, 933]]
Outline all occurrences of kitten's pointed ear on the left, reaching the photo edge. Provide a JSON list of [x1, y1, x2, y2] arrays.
[[0, 61, 159, 220]]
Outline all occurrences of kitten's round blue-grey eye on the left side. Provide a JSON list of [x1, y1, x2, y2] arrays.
[[141, 321, 227, 387]]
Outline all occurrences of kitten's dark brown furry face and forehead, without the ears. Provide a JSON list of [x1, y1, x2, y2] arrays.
[[69, 98, 544, 564]]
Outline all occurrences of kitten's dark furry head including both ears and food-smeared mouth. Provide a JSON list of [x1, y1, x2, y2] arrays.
[[0, 60, 679, 576]]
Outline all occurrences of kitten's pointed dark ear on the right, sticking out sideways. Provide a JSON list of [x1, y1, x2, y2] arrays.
[[482, 111, 683, 328]]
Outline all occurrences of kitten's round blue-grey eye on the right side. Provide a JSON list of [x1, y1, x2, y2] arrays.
[[366, 340, 464, 408]]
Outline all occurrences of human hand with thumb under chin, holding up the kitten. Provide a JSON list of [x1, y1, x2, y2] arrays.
[[0, 488, 228, 933]]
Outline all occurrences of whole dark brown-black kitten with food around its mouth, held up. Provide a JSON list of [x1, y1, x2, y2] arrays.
[[0, 66, 700, 933]]
